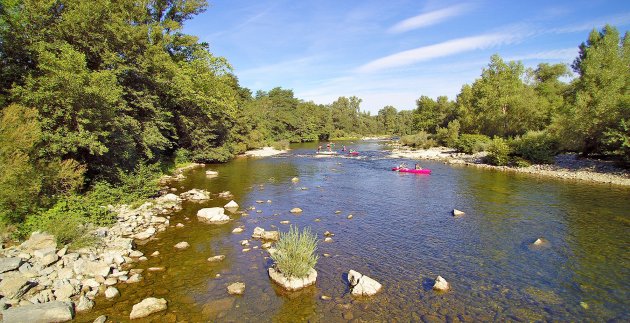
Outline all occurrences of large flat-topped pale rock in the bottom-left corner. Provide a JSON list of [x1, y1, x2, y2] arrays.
[[2, 301, 74, 323]]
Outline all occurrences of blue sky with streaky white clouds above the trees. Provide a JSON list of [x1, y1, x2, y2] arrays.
[[184, 0, 630, 114]]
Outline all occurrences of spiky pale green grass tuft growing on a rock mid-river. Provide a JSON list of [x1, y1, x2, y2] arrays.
[[271, 226, 318, 278]]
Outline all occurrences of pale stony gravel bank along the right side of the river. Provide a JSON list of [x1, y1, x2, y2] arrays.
[[390, 146, 630, 186]]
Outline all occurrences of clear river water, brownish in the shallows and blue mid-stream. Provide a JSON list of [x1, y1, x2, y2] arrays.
[[76, 142, 630, 322]]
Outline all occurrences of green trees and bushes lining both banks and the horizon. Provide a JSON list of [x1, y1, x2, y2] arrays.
[[0, 0, 630, 234]]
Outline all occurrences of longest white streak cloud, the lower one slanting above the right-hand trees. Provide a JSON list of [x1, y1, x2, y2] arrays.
[[357, 33, 519, 73]]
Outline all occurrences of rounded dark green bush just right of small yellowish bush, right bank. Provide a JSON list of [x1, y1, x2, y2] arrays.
[[512, 131, 559, 164]]
